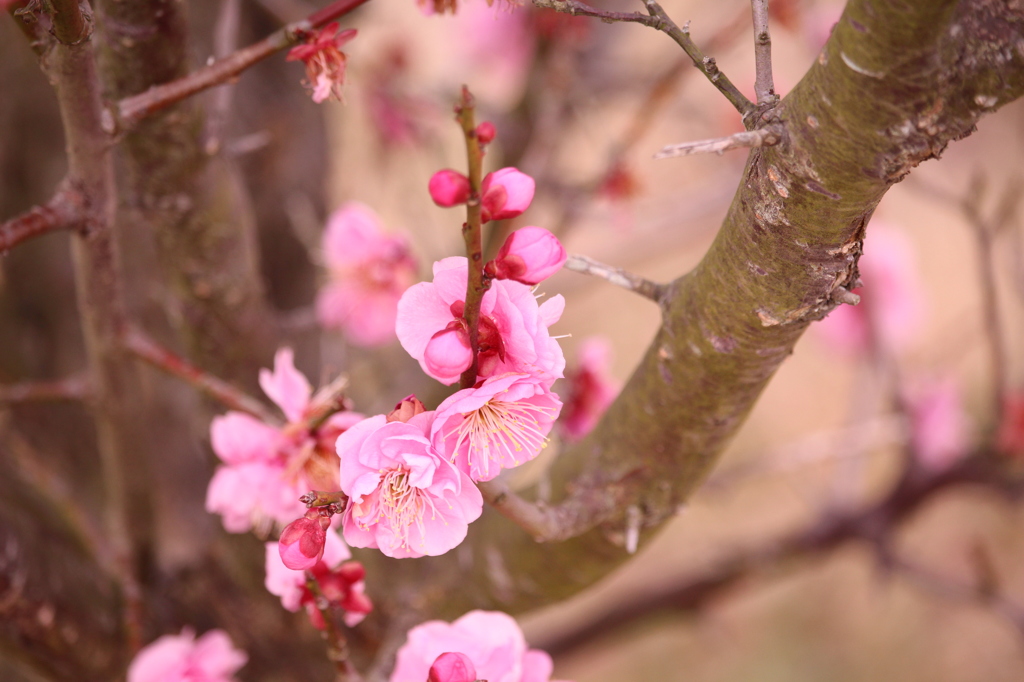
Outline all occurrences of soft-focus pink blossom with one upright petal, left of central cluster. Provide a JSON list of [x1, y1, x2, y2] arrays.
[[206, 348, 362, 532]]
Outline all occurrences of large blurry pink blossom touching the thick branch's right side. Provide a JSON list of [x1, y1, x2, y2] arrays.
[[817, 225, 924, 353]]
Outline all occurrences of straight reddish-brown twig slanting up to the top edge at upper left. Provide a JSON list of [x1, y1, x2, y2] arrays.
[[111, 0, 367, 128]]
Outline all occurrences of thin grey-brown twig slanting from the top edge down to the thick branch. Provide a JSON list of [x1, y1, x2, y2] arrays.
[[534, 0, 756, 115]]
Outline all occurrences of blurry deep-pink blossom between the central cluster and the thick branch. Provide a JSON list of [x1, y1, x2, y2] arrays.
[[558, 337, 621, 440]]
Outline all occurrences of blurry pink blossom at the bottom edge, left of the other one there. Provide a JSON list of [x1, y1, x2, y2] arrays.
[[128, 628, 249, 682]]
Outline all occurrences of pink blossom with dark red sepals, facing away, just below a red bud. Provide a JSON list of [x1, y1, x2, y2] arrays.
[[264, 530, 373, 629]]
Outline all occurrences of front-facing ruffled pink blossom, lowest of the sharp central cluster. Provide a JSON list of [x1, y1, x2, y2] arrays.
[[338, 412, 483, 557]]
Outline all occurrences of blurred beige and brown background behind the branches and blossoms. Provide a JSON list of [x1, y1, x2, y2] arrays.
[[0, 0, 1024, 682]]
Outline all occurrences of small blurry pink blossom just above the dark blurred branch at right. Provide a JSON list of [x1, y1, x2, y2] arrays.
[[908, 381, 970, 472]]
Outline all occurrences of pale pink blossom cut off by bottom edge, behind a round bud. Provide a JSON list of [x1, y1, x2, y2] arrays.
[[390, 611, 569, 682]]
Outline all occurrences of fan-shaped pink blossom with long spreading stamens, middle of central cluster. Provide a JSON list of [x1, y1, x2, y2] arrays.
[[430, 374, 562, 481]]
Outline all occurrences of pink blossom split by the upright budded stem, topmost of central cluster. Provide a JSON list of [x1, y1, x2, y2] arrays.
[[395, 257, 565, 385]]
